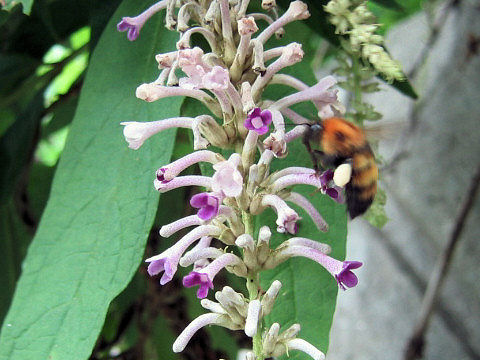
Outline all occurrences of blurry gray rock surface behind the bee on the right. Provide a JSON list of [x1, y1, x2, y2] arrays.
[[327, 1, 480, 360]]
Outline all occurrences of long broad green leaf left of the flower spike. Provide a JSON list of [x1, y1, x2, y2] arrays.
[[0, 0, 181, 360]]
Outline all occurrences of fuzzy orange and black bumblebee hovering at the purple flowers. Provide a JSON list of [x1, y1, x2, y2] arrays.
[[303, 117, 378, 219]]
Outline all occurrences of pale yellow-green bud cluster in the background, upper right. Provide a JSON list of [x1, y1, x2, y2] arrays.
[[325, 0, 405, 81]]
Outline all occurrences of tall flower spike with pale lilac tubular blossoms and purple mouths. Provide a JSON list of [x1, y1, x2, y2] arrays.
[[118, 0, 362, 360]]
